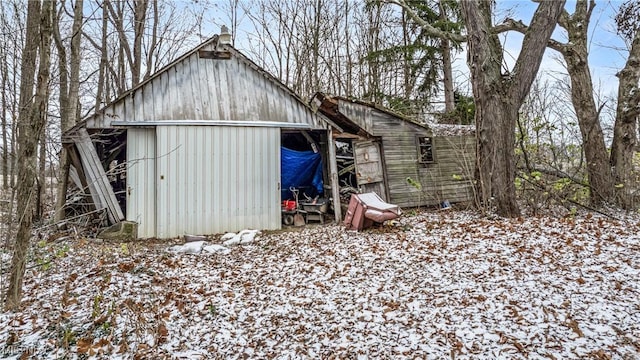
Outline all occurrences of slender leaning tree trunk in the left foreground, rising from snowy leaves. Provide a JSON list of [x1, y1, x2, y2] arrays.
[[5, 0, 53, 310]]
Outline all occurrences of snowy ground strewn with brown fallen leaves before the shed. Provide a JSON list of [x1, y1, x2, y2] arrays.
[[0, 212, 640, 359]]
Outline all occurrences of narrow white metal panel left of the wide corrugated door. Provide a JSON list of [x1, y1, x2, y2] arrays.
[[126, 128, 156, 238]]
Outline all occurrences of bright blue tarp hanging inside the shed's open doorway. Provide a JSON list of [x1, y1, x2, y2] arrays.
[[280, 147, 324, 200]]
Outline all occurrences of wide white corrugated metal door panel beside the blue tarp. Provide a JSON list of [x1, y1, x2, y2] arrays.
[[156, 126, 281, 238]]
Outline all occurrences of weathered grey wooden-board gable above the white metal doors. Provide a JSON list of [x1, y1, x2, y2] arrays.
[[87, 44, 327, 129]]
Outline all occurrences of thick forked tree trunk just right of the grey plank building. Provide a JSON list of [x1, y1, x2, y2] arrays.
[[460, 0, 565, 217]]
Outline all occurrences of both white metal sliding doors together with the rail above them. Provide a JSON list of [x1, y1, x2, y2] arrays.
[[122, 121, 308, 238]]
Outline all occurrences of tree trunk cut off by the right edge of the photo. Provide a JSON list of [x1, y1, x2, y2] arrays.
[[611, 26, 640, 209]]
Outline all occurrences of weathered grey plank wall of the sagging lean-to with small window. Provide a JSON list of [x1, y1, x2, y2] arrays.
[[339, 101, 475, 207]]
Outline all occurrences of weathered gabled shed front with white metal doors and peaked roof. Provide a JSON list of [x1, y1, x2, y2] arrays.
[[68, 32, 341, 238]]
